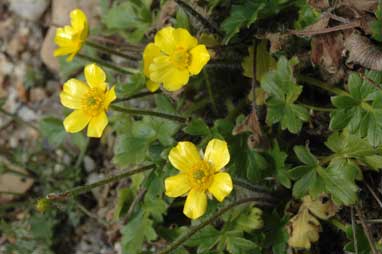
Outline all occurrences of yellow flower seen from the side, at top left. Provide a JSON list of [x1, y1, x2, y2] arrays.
[[54, 9, 89, 61]]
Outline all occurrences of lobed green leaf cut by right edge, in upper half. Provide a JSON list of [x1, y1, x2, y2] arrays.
[[329, 71, 382, 146]]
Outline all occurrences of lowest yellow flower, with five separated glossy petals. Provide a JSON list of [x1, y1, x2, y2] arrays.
[[165, 139, 232, 219]]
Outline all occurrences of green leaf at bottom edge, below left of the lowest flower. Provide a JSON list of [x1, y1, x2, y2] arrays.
[[121, 211, 157, 254]]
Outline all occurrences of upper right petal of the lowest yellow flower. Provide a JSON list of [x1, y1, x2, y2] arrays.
[[204, 138, 230, 171]]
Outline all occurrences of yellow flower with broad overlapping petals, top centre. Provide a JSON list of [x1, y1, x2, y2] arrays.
[[143, 27, 210, 91]]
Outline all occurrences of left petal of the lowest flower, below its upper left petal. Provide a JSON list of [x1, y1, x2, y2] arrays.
[[164, 173, 191, 198]]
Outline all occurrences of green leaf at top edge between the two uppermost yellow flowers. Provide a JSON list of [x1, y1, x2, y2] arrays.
[[101, 0, 153, 43]]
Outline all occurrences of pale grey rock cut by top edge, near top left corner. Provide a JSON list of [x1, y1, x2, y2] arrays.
[[10, 0, 50, 21]]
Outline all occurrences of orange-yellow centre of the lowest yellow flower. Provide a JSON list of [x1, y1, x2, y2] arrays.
[[189, 161, 214, 191]]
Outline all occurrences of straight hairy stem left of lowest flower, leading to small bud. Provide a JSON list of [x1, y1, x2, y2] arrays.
[[46, 164, 155, 201]]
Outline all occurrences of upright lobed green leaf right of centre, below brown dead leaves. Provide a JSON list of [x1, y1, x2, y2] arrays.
[[261, 57, 309, 133]]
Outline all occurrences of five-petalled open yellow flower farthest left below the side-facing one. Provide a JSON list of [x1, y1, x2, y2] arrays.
[[60, 64, 116, 138]]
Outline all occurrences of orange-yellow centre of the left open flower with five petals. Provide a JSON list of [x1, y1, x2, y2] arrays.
[[82, 88, 105, 116]]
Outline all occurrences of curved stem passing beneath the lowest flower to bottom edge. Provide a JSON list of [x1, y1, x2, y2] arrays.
[[158, 197, 271, 254]]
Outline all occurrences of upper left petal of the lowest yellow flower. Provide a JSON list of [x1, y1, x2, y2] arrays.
[[168, 141, 201, 171]]
